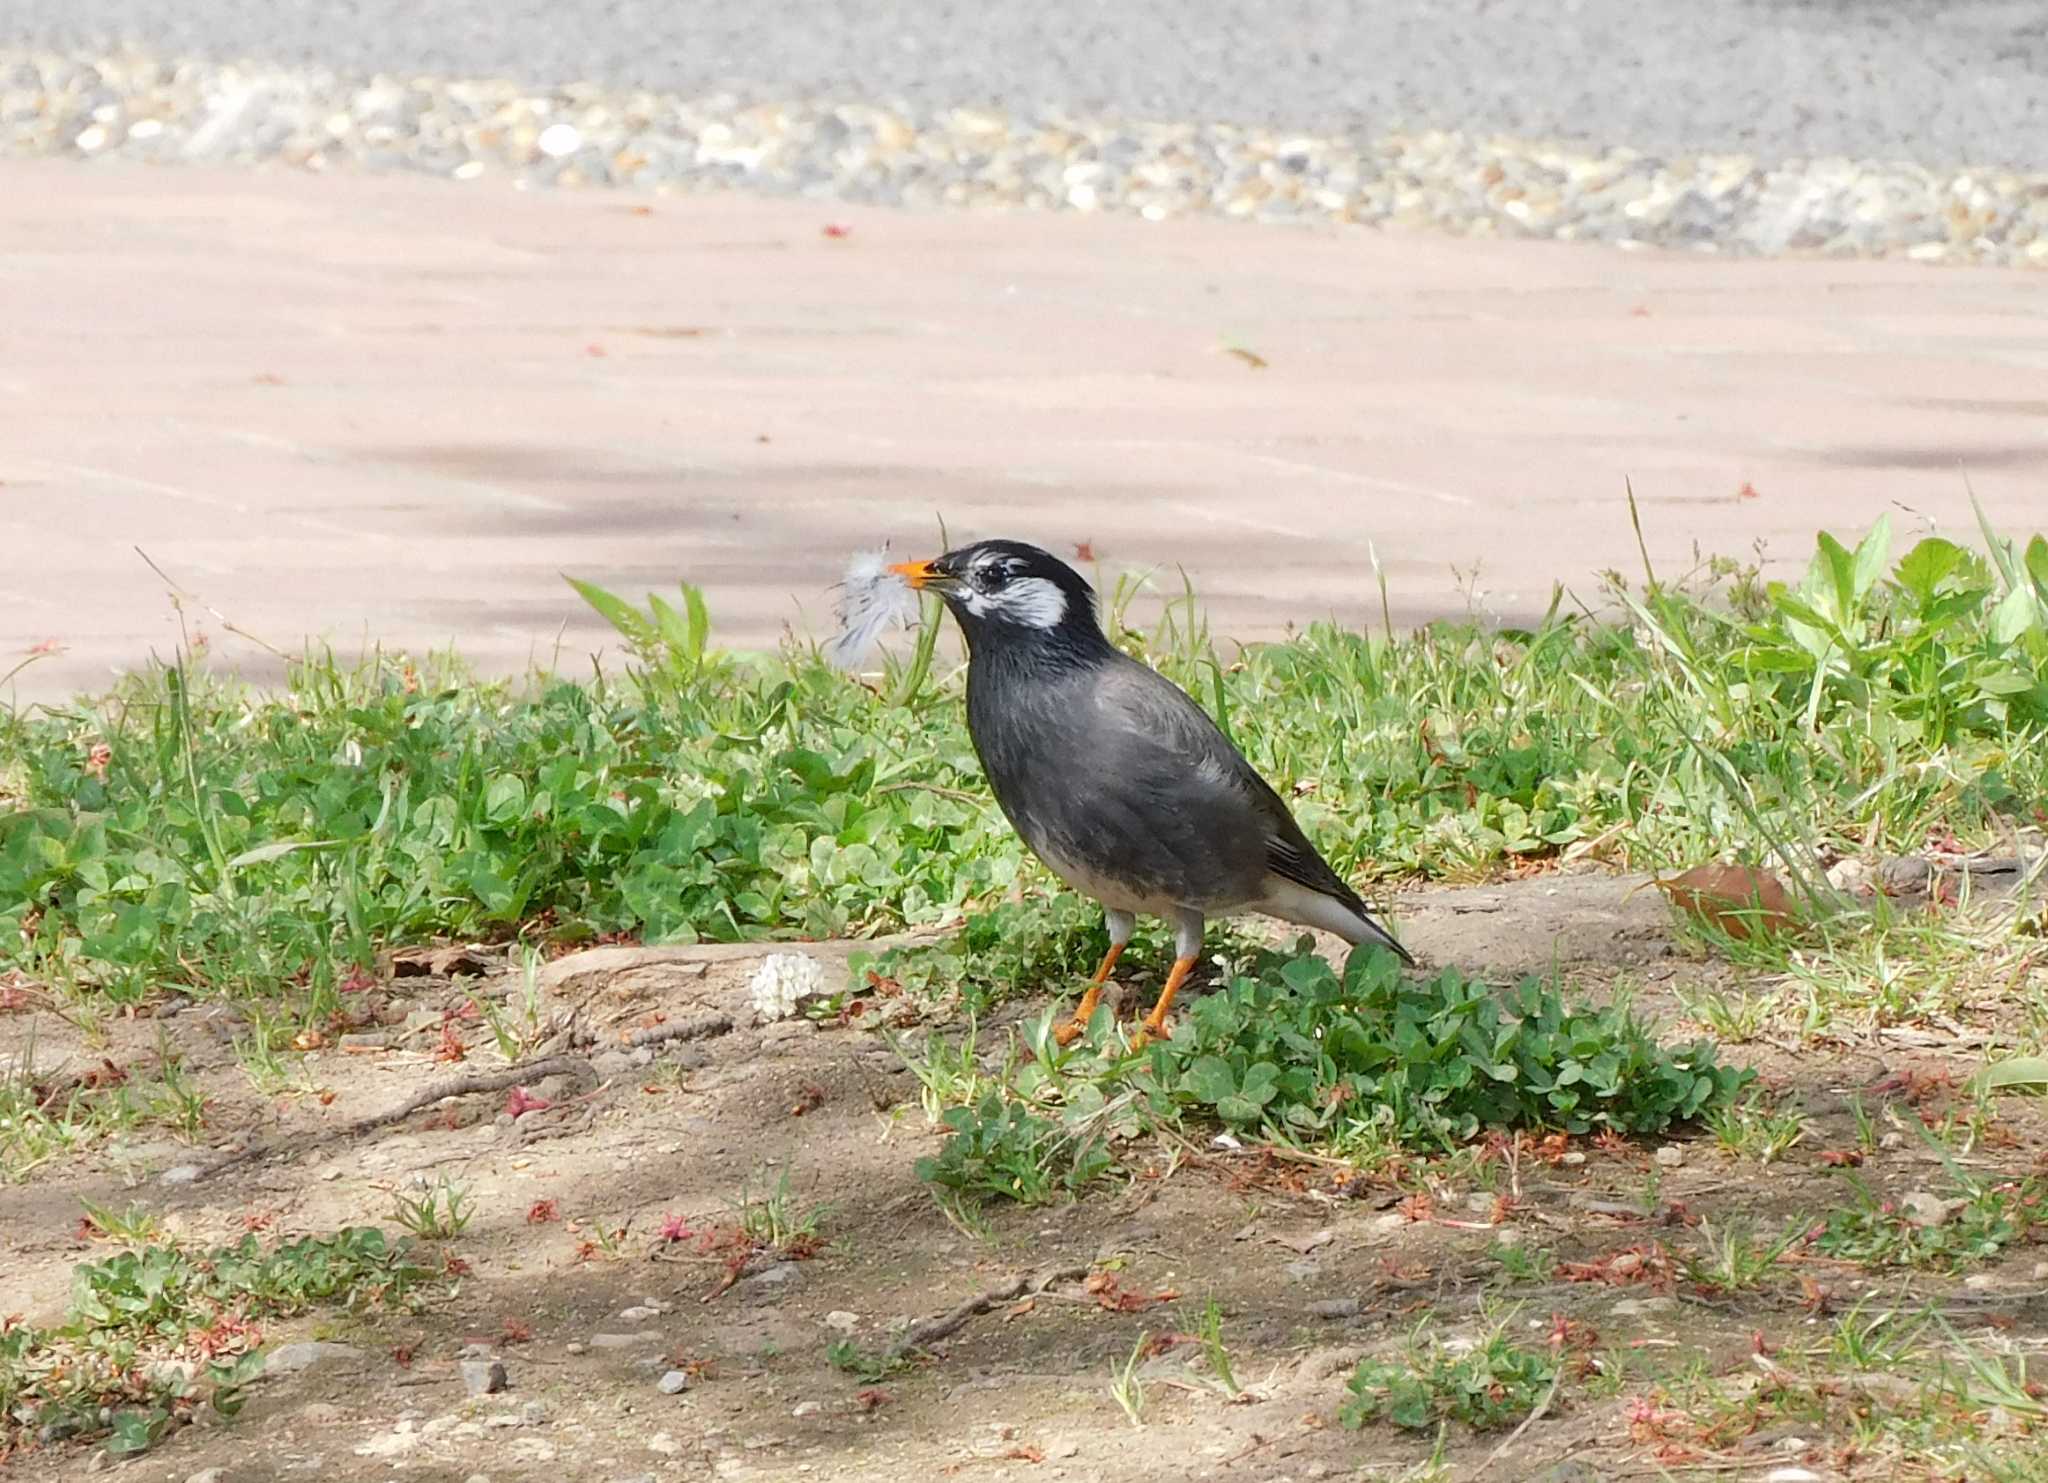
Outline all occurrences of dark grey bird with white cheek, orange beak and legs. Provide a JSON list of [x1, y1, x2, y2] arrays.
[[889, 541, 1415, 1045]]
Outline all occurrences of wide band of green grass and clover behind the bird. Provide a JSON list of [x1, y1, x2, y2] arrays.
[[0, 510, 2048, 1012]]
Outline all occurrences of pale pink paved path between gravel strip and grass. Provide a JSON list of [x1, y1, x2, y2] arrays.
[[0, 162, 2048, 698]]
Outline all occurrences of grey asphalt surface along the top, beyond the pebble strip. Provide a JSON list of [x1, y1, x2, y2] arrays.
[[12, 0, 2048, 168]]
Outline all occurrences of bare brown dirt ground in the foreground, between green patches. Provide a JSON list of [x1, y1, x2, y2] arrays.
[[0, 873, 2042, 1483]]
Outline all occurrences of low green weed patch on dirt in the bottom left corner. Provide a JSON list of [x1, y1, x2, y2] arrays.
[[0, 1219, 432, 1463]]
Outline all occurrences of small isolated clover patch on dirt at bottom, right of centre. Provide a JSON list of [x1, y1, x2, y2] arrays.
[[1337, 1325, 1559, 1432]]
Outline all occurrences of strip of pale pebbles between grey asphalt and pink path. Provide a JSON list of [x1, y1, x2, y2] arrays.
[[0, 49, 2048, 266]]
